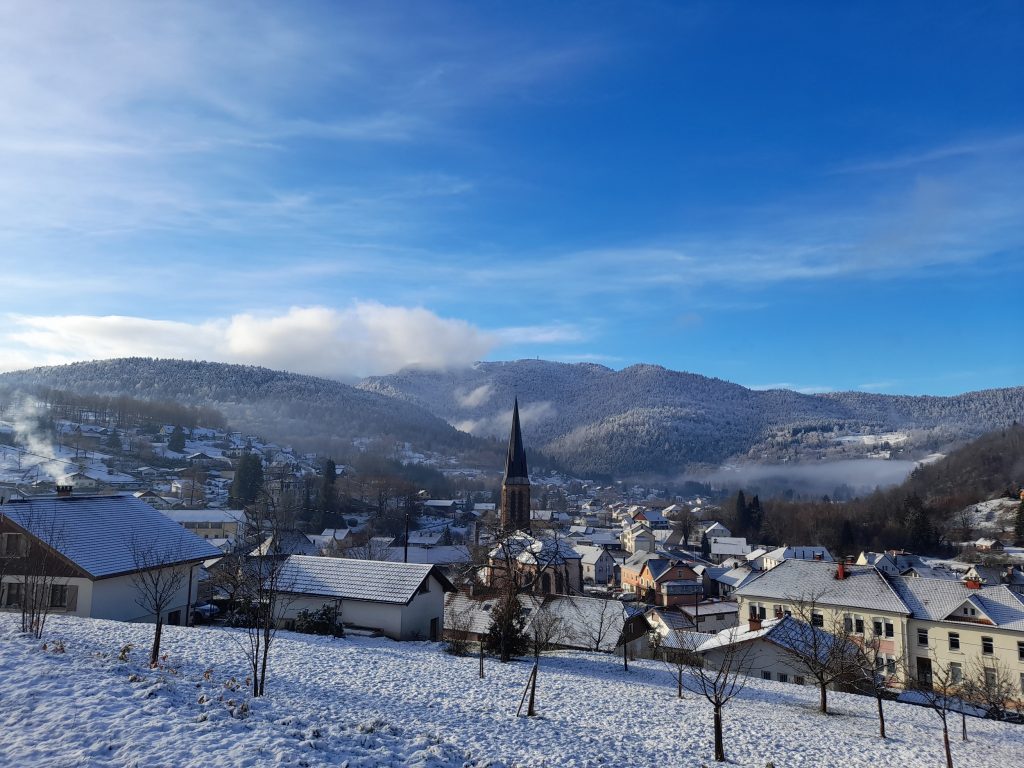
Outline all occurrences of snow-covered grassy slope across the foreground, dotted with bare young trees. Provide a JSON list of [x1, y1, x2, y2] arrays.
[[0, 615, 1024, 768]]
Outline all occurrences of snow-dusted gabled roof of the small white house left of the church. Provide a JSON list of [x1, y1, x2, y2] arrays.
[[281, 555, 451, 605]]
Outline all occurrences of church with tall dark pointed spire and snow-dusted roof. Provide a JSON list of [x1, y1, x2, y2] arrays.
[[486, 397, 583, 595]]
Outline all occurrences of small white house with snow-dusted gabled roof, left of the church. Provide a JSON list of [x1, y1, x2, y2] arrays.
[[280, 555, 455, 640]]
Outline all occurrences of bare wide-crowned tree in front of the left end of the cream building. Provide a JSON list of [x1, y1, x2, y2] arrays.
[[773, 594, 859, 714]]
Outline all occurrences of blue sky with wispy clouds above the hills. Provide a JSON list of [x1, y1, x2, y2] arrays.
[[0, 2, 1024, 394]]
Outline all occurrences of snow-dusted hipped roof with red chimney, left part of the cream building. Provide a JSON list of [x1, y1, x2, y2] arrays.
[[735, 560, 910, 613]]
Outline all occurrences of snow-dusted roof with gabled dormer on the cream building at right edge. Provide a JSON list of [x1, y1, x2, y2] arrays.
[[890, 577, 1024, 631]]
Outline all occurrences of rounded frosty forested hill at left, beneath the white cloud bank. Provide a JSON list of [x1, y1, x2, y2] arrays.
[[0, 357, 477, 454]]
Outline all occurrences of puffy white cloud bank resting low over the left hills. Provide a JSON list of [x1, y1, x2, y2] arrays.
[[0, 302, 497, 378]]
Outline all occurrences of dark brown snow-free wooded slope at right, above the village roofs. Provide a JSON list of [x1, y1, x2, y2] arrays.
[[723, 423, 1024, 555]]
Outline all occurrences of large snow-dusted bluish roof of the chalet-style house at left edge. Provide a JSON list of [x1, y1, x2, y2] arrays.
[[0, 496, 223, 579]]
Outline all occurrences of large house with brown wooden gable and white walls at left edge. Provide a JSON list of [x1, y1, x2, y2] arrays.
[[0, 496, 221, 625]]
